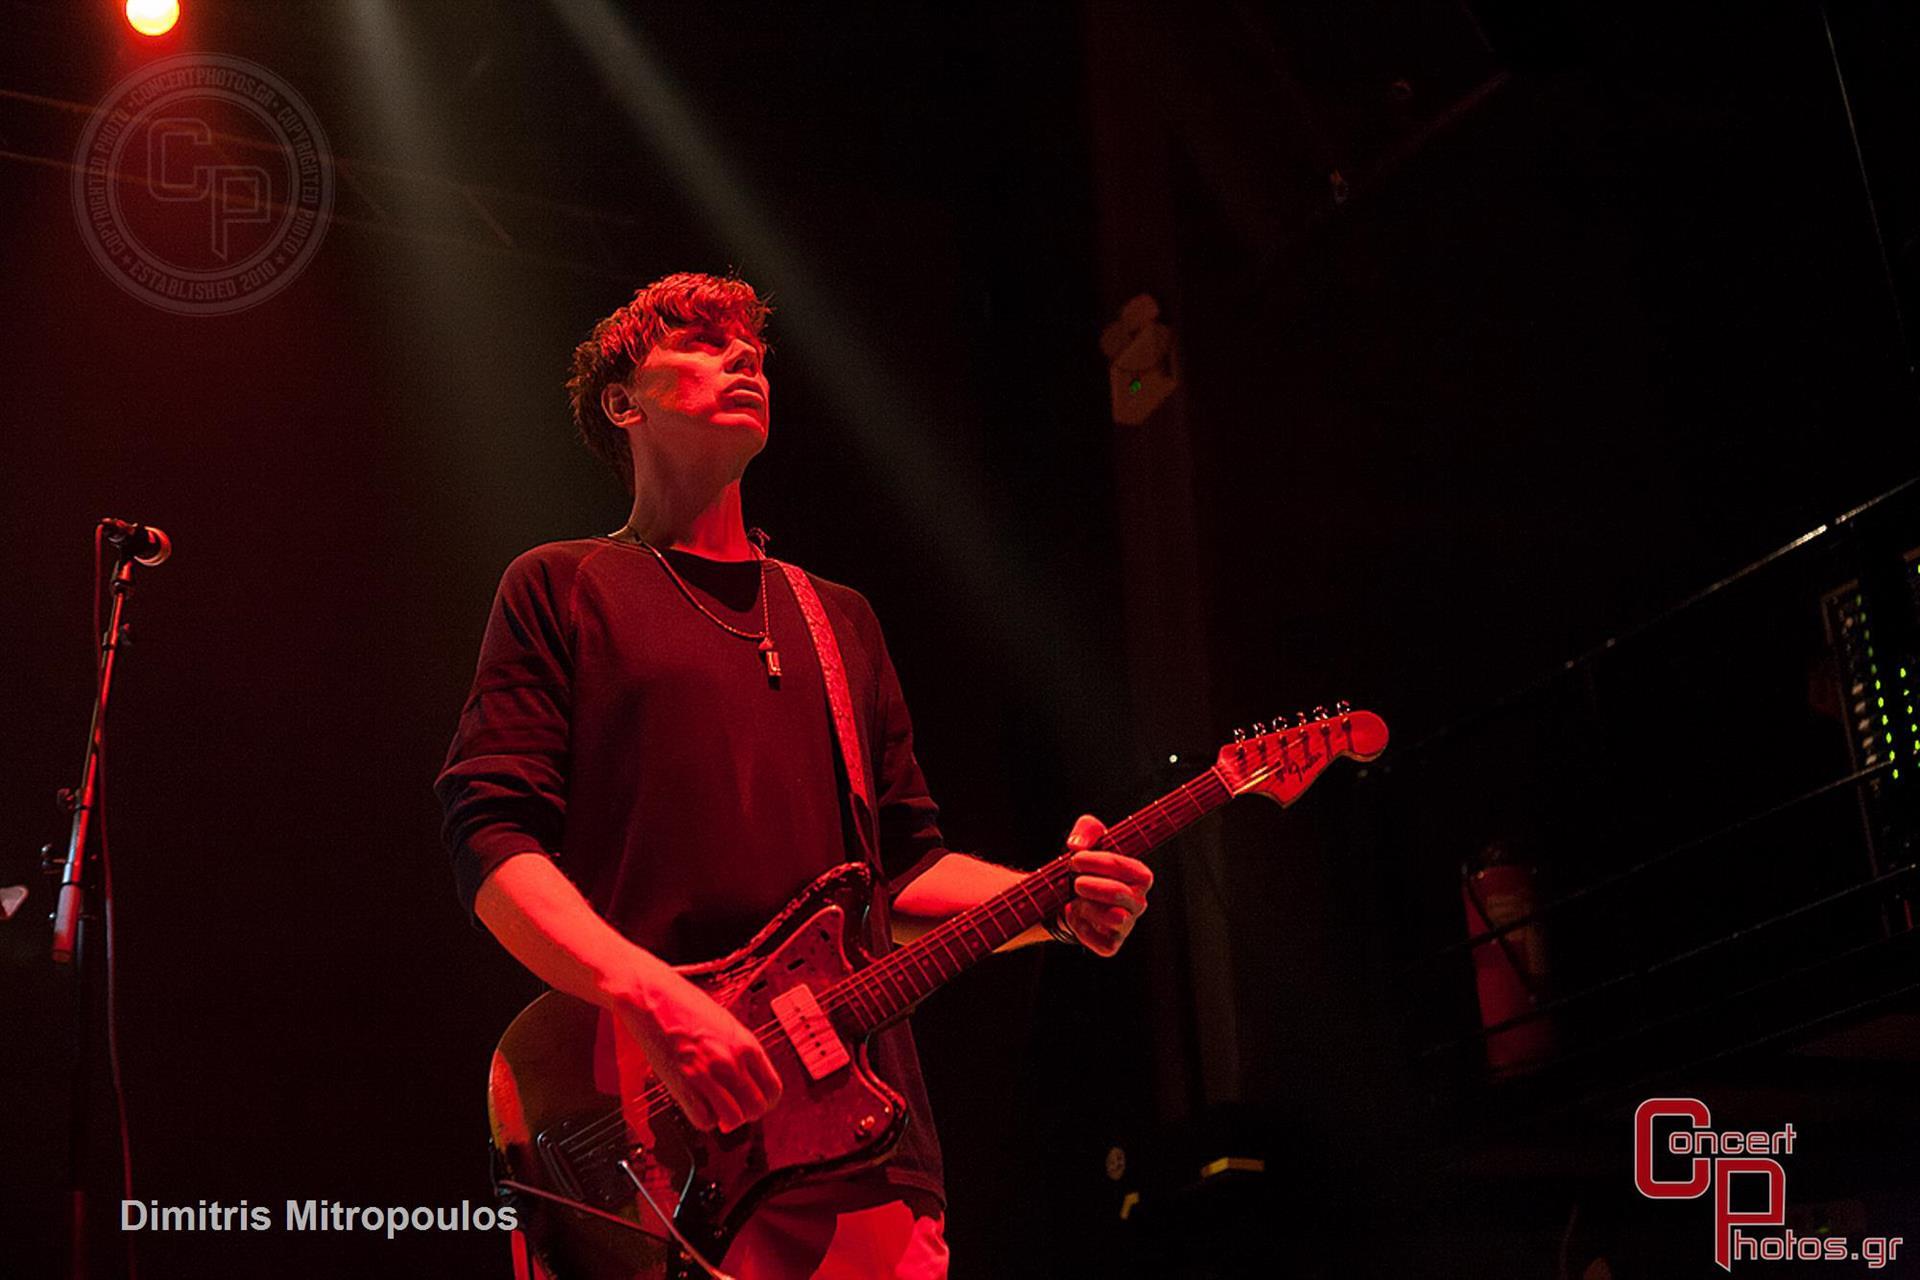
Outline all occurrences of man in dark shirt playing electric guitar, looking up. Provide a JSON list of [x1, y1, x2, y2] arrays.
[[436, 274, 1152, 1280]]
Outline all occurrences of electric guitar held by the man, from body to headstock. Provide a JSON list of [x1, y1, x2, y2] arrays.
[[488, 702, 1386, 1280]]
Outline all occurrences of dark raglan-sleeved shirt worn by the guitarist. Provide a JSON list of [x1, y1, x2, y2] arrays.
[[436, 537, 947, 1197]]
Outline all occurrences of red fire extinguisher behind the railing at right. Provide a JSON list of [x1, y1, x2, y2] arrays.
[[1459, 841, 1553, 1075]]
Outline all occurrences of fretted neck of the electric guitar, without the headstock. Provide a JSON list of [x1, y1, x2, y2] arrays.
[[828, 768, 1235, 1034]]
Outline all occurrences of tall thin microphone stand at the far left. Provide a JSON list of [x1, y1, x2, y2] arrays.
[[54, 547, 134, 1280]]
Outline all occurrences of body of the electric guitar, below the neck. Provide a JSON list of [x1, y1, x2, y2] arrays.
[[488, 864, 906, 1280]]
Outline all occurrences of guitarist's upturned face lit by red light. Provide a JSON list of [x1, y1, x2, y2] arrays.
[[632, 324, 770, 457]]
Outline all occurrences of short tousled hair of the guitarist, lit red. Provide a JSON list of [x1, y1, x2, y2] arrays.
[[566, 271, 772, 493]]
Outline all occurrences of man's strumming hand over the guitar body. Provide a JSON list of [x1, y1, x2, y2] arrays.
[[603, 958, 780, 1132]]
